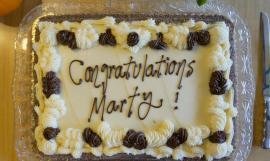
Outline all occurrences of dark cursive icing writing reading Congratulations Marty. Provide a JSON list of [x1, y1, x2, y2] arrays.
[[69, 54, 196, 122]]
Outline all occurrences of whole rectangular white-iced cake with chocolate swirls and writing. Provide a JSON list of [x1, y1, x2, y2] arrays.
[[33, 17, 237, 161]]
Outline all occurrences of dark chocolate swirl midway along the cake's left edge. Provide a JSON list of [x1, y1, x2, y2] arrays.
[[42, 71, 60, 98]]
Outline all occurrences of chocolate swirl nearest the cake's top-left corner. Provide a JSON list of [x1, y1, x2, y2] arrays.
[[56, 30, 78, 49]]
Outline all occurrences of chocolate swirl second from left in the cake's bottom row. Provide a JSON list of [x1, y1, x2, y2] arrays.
[[83, 128, 102, 147]]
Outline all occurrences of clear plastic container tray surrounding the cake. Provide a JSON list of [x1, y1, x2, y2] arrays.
[[13, 0, 255, 161]]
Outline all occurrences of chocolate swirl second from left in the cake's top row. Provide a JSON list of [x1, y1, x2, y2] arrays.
[[98, 28, 116, 46]]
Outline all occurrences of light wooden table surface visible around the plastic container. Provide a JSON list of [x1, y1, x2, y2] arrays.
[[0, 0, 270, 161]]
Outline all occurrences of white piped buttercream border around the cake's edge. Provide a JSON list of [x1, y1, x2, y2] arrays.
[[34, 17, 237, 160]]
